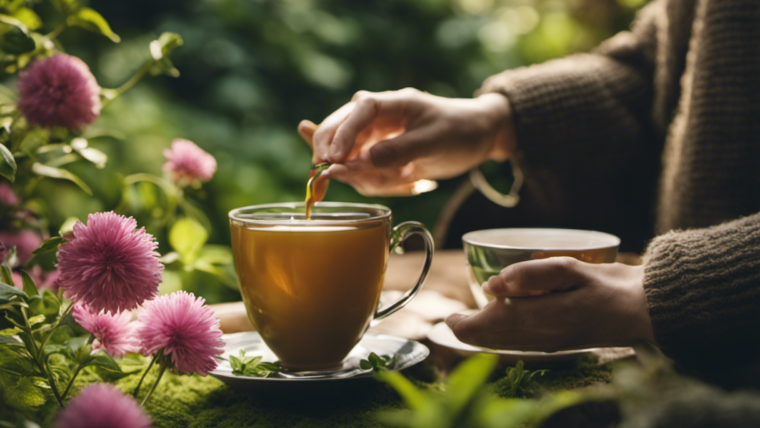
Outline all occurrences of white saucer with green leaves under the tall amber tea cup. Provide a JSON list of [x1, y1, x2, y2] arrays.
[[209, 331, 430, 389]]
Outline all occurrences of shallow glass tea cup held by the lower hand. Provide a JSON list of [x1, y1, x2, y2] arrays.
[[462, 228, 620, 309]]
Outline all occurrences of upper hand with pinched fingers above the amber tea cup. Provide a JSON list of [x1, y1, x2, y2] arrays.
[[299, 88, 515, 196]]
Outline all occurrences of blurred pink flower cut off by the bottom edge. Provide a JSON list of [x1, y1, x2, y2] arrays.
[[55, 383, 152, 428]]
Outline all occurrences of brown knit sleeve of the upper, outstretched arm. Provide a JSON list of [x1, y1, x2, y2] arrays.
[[480, 1, 662, 170]]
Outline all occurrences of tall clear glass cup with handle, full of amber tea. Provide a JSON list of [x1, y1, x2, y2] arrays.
[[230, 202, 433, 371]]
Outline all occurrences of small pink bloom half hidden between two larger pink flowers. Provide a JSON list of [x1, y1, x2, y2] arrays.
[[72, 303, 140, 358]]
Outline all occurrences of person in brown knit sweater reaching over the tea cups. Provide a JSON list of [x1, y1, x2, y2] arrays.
[[299, 0, 760, 392]]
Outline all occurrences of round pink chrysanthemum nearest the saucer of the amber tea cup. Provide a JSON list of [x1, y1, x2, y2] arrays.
[[137, 291, 224, 376]]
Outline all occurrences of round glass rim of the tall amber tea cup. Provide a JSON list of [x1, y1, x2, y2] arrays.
[[227, 202, 391, 227]]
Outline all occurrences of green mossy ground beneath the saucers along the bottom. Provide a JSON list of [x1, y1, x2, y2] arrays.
[[101, 354, 612, 428]]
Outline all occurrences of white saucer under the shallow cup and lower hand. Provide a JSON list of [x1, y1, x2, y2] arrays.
[[428, 322, 599, 364]]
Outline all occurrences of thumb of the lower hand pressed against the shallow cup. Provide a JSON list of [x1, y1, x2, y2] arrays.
[[483, 257, 586, 297]]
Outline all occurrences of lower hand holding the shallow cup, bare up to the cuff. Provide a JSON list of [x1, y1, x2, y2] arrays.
[[446, 257, 654, 352]]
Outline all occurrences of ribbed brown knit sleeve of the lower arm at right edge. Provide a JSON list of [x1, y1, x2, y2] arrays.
[[644, 213, 760, 377]]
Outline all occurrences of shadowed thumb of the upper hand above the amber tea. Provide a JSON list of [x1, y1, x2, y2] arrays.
[[369, 129, 432, 168]]
